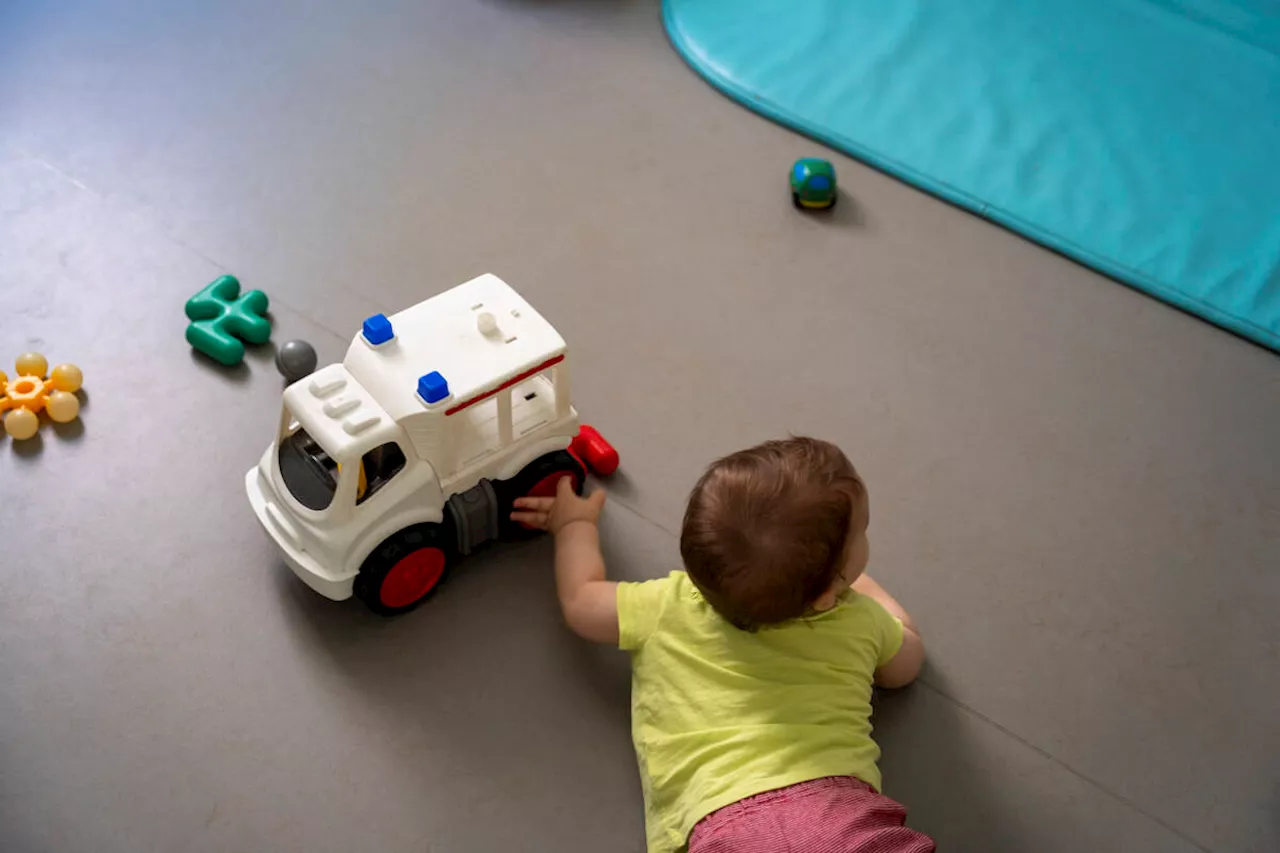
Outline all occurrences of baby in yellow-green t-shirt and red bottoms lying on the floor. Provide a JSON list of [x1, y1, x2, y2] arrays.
[[512, 438, 934, 853]]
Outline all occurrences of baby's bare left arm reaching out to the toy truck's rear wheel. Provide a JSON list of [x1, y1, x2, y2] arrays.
[[511, 476, 618, 646]]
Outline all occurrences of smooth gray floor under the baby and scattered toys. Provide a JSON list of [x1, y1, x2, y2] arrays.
[[0, 0, 1280, 853]]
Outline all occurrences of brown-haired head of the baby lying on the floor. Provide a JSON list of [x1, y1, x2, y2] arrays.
[[680, 438, 869, 630]]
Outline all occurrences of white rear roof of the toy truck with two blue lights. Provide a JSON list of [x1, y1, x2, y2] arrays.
[[343, 273, 564, 421]]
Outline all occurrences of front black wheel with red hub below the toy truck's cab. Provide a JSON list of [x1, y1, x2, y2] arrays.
[[353, 524, 457, 616]]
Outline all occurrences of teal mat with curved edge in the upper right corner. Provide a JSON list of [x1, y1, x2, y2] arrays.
[[664, 0, 1280, 350]]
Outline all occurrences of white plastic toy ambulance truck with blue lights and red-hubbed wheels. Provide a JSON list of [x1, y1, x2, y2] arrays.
[[244, 274, 617, 615]]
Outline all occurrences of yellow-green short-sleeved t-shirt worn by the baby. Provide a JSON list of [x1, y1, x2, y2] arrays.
[[618, 571, 902, 853]]
